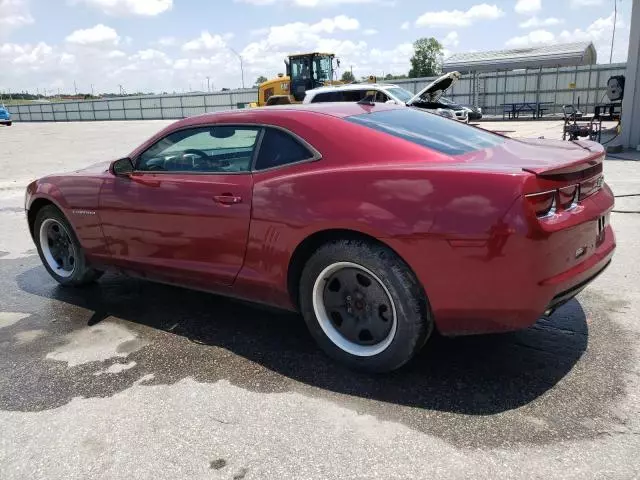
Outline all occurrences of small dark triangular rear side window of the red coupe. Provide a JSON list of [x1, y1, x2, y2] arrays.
[[255, 128, 314, 170]]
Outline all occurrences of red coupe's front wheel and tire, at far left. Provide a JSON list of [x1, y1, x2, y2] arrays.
[[33, 205, 102, 287]]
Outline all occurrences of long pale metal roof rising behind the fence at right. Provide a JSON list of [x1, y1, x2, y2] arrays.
[[442, 42, 597, 73]]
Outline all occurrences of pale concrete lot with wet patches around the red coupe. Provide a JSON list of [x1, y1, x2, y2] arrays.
[[0, 121, 640, 479]]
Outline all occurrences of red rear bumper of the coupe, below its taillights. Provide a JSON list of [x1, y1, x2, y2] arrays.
[[400, 188, 616, 335]]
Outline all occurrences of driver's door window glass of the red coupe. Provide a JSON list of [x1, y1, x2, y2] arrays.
[[136, 125, 260, 173]]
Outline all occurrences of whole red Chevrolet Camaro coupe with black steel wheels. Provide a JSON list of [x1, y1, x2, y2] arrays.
[[26, 103, 615, 371]]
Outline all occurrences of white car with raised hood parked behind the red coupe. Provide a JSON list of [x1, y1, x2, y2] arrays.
[[303, 72, 470, 122]]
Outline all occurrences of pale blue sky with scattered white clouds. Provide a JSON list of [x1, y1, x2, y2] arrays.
[[0, 0, 634, 94]]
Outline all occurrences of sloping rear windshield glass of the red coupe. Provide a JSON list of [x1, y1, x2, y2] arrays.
[[345, 108, 504, 155]]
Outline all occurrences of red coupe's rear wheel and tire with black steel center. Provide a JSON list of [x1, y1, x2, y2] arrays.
[[300, 240, 433, 372]]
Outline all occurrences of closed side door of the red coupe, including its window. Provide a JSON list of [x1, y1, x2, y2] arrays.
[[100, 125, 262, 287]]
